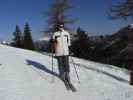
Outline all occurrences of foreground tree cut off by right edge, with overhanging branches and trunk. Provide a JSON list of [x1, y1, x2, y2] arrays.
[[110, 0, 133, 85]]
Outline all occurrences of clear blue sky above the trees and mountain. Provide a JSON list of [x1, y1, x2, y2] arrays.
[[0, 0, 131, 40]]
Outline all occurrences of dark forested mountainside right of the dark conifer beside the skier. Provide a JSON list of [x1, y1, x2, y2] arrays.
[[78, 24, 133, 69]]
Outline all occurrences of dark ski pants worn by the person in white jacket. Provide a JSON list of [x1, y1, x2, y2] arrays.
[[56, 56, 70, 76]]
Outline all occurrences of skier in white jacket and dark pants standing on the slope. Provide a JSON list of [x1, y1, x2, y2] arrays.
[[52, 25, 71, 82]]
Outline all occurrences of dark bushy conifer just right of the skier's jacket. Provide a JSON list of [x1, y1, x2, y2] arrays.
[[71, 28, 90, 59]]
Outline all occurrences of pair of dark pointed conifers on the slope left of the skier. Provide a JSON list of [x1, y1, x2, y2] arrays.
[[11, 23, 35, 50]]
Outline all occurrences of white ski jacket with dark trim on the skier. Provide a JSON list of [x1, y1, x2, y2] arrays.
[[52, 29, 71, 56]]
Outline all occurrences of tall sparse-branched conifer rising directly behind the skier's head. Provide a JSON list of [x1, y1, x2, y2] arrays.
[[46, 0, 75, 32]]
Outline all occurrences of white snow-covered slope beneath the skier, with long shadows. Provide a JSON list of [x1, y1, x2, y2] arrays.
[[0, 45, 133, 100]]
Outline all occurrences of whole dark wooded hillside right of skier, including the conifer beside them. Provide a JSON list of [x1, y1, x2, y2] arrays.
[[71, 26, 133, 69]]
